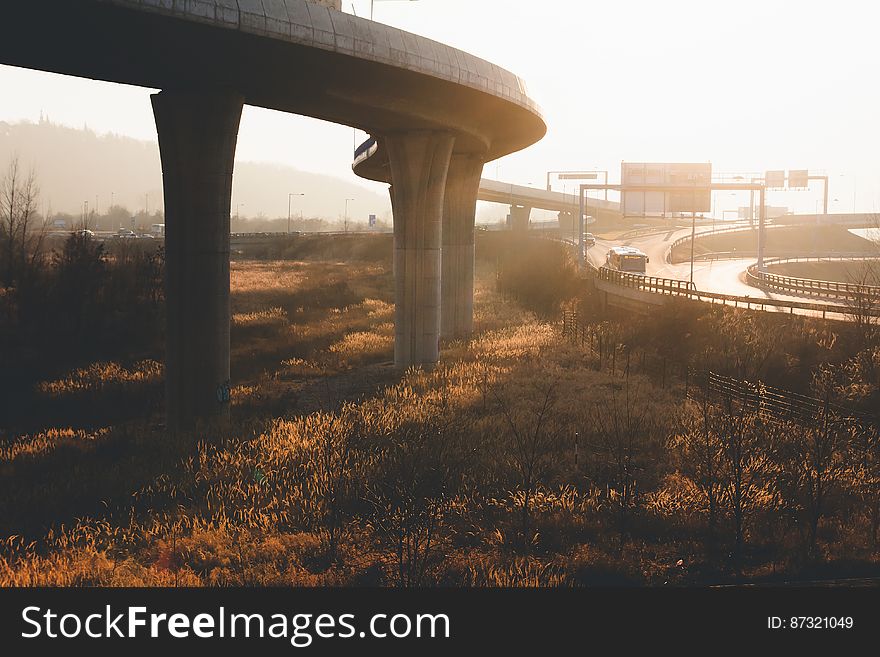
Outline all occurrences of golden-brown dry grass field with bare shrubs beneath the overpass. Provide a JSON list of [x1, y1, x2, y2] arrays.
[[0, 234, 880, 586]]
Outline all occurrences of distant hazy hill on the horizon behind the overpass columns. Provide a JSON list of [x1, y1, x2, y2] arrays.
[[0, 120, 391, 222]]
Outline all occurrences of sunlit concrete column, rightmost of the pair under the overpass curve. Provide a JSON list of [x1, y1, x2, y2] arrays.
[[440, 153, 483, 338]]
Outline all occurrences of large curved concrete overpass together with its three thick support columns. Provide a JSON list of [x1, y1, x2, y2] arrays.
[[0, 0, 546, 429]]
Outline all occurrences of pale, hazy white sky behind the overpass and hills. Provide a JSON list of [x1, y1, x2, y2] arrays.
[[0, 0, 880, 217]]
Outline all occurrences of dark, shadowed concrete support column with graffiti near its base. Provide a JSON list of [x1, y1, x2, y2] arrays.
[[152, 91, 243, 430]]
